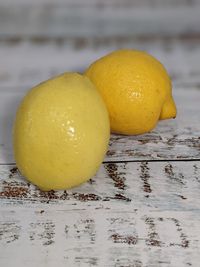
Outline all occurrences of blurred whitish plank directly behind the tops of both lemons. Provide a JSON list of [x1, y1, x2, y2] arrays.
[[0, 36, 200, 91]]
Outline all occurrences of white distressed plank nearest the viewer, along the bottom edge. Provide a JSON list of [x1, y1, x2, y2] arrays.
[[0, 209, 200, 267]]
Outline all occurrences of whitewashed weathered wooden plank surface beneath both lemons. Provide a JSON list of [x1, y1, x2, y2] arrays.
[[0, 0, 200, 267]]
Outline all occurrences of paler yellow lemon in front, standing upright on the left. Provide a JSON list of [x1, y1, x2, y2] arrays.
[[13, 73, 110, 190]]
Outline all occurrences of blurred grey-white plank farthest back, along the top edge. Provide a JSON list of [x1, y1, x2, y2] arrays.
[[0, 0, 200, 37]]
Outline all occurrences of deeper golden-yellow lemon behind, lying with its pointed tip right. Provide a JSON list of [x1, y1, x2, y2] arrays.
[[85, 50, 176, 135]]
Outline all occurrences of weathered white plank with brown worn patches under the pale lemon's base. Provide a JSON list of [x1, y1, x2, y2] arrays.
[[0, 161, 200, 212]]
